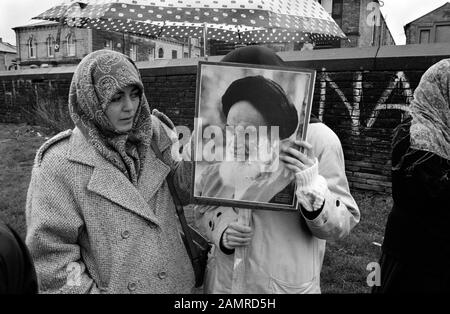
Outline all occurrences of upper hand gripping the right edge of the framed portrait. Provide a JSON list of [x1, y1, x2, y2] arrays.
[[280, 140, 315, 174]]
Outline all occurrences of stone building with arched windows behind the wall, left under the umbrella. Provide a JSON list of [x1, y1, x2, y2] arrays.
[[14, 22, 200, 68]]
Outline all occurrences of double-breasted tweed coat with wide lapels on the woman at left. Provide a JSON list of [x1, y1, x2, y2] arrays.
[[26, 116, 194, 293]]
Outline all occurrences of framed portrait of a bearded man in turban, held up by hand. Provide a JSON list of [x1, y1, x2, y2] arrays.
[[191, 61, 316, 210]]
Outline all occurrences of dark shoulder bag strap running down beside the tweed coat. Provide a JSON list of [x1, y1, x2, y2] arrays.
[[151, 141, 199, 261]]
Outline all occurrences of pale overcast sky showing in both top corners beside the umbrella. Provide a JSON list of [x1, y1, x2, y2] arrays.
[[0, 0, 447, 44]]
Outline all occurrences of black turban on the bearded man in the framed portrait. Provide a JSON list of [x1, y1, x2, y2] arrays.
[[222, 75, 298, 139]]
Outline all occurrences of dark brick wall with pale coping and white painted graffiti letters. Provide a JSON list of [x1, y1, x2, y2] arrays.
[[0, 44, 450, 192]]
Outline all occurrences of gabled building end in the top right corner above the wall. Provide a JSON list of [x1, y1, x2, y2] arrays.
[[404, 2, 450, 44]]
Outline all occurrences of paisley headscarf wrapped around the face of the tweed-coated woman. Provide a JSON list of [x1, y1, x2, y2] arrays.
[[69, 50, 152, 186]]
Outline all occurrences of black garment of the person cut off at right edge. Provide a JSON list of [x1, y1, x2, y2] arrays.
[[381, 120, 450, 292]]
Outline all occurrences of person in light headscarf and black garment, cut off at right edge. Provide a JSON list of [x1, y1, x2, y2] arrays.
[[374, 59, 450, 293]]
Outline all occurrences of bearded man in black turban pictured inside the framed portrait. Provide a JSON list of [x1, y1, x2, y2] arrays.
[[195, 75, 299, 205]]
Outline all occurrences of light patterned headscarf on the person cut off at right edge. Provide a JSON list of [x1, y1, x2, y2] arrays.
[[410, 59, 450, 160]]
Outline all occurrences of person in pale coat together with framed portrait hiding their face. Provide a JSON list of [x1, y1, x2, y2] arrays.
[[194, 46, 360, 294]]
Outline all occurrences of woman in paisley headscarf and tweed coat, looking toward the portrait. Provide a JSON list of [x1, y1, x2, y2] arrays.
[[26, 50, 194, 293]]
